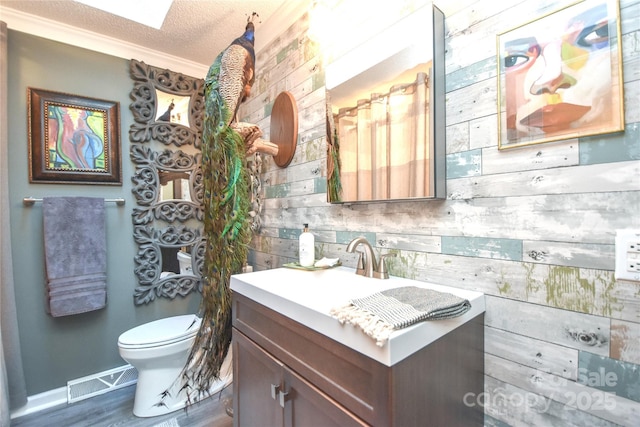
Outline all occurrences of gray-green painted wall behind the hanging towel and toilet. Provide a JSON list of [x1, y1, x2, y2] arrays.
[[8, 31, 199, 395]]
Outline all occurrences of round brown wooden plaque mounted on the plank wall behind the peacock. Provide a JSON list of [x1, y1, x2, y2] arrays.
[[269, 92, 298, 168]]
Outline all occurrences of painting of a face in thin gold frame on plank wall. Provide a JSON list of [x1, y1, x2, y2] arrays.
[[497, 0, 624, 149]]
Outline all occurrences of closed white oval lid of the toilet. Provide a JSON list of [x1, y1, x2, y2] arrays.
[[118, 314, 201, 347]]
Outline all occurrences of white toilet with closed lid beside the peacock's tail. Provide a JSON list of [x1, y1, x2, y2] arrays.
[[118, 314, 232, 417]]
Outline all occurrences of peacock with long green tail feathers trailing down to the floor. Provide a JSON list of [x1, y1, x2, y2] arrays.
[[183, 12, 257, 400]]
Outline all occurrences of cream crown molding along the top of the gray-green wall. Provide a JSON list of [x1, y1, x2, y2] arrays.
[[0, 6, 209, 78]]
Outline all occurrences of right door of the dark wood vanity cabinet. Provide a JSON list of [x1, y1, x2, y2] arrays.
[[284, 367, 367, 427]]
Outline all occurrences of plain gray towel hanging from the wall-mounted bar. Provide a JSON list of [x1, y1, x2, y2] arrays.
[[42, 197, 107, 317]]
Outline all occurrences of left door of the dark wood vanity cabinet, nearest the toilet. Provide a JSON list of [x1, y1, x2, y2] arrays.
[[233, 329, 283, 427]]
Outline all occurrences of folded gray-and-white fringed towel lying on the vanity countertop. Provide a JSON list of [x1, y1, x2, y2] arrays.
[[331, 286, 471, 347]]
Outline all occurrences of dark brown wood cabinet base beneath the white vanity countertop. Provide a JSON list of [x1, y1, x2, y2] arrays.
[[233, 293, 484, 427]]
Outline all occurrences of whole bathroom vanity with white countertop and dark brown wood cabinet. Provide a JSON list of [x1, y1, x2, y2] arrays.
[[231, 267, 485, 427]]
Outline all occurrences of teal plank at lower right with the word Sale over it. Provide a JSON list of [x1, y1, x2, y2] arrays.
[[578, 351, 640, 402]]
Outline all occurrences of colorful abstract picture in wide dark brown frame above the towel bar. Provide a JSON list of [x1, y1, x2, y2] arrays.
[[27, 88, 122, 185]]
